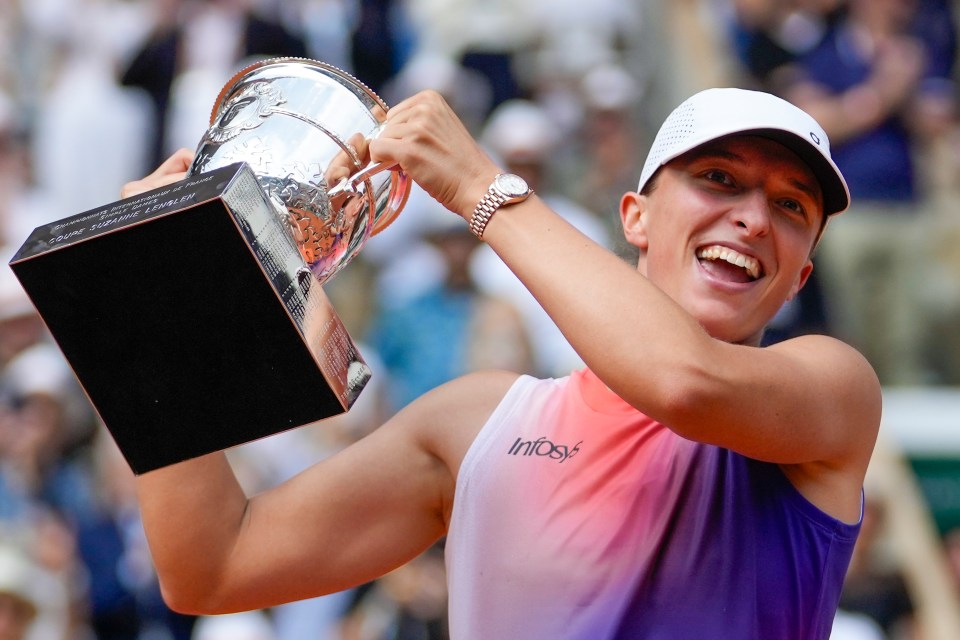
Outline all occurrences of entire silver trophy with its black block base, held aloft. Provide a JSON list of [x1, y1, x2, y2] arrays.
[[10, 58, 410, 473]]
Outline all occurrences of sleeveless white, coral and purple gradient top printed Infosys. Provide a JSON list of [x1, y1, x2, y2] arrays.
[[446, 370, 860, 640]]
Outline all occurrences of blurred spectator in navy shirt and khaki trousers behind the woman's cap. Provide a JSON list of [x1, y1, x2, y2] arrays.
[[785, 0, 956, 384]]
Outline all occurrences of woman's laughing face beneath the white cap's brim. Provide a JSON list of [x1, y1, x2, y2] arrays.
[[621, 135, 823, 344]]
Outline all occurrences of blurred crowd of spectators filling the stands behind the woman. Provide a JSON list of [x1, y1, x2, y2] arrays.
[[0, 0, 960, 640]]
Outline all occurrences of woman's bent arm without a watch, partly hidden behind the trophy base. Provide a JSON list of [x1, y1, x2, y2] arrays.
[[123, 151, 516, 614]]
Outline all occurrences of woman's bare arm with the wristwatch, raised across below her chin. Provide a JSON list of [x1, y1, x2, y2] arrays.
[[372, 94, 880, 510]]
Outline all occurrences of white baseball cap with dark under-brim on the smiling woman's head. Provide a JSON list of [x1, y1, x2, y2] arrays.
[[637, 89, 850, 215]]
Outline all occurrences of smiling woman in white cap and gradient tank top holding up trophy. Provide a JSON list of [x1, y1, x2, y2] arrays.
[[125, 89, 880, 640]]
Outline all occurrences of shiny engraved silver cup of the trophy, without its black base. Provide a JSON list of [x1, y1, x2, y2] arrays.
[[190, 58, 410, 282]]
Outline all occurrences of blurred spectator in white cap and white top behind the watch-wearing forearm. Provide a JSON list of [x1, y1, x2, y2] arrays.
[[471, 100, 610, 375]]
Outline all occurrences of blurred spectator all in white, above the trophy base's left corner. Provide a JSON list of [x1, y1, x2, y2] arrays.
[[26, 0, 150, 220]]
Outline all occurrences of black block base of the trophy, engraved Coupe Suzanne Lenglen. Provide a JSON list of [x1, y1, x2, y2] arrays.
[[11, 165, 370, 474]]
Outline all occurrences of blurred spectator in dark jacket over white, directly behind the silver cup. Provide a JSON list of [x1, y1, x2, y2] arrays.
[[120, 0, 307, 166]]
